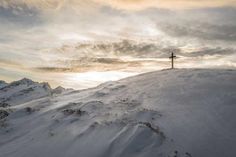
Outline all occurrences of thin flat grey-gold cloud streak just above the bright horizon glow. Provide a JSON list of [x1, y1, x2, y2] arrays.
[[33, 58, 165, 72]]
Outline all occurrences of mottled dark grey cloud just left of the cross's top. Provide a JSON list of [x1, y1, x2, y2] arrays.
[[53, 40, 172, 58]]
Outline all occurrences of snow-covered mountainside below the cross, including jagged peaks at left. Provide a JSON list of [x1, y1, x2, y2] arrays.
[[0, 69, 236, 157]]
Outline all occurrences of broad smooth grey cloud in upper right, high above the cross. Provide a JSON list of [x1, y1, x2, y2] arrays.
[[138, 7, 236, 42]]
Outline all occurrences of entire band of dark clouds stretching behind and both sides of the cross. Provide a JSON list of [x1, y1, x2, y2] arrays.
[[30, 40, 236, 72]]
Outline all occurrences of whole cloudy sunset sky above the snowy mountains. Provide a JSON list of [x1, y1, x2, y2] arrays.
[[0, 0, 236, 89]]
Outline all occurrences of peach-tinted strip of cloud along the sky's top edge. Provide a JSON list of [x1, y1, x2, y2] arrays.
[[0, 0, 236, 10]]
